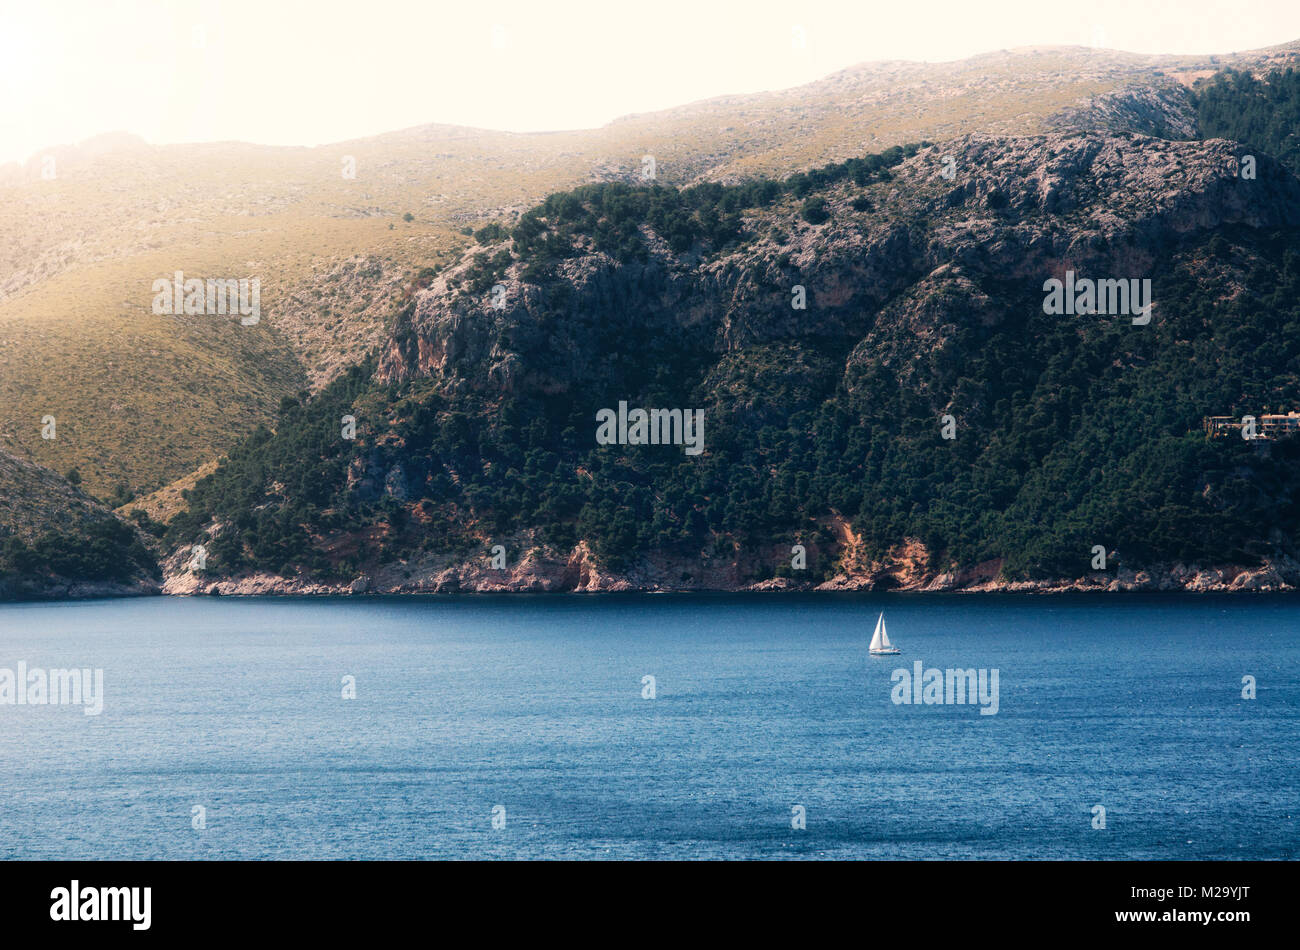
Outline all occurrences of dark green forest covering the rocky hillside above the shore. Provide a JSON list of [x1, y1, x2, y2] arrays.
[[168, 136, 1300, 580]]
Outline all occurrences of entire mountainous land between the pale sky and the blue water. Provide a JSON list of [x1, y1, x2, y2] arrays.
[[0, 44, 1300, 590]]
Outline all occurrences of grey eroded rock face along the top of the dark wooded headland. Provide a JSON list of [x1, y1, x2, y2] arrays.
[[377, 133, 1300, 392]]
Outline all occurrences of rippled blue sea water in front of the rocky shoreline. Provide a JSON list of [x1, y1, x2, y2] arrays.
[[0, 595, 1300, 859]]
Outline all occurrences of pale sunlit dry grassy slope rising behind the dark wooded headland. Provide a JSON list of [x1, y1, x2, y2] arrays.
[[0, 45, 1296, 494]]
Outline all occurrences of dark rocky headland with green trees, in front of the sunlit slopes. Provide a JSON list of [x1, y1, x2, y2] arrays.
[[166, 124, 1300, 591]]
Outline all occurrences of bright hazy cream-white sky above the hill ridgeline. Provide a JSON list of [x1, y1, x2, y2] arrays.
[[0, 0, 1300, 161]]
